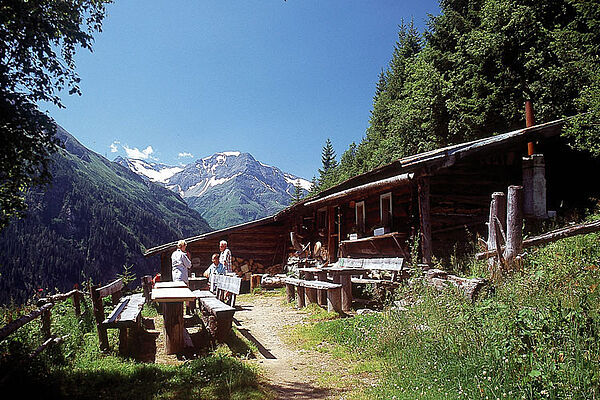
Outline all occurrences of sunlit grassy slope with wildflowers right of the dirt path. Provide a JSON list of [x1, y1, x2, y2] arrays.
[[295, 227, 600, 399]]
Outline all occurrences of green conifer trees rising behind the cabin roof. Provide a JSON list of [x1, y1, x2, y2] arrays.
[[330, 0, 600, 188]]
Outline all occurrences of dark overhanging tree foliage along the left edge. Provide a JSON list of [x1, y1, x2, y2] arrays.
[[0, 0, 110, 229]]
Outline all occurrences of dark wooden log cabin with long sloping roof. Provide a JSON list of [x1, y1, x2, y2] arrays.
[[145, 120, 600, 278]]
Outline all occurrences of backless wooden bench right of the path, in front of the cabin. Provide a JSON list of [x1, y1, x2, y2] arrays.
[[283, 278, 342, 313]]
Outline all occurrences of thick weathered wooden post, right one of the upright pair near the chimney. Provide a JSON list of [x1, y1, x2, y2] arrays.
[[504, 186, 523, 265]]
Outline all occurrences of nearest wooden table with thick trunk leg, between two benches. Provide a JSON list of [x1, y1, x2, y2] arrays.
[[152, 288, 196, 354]]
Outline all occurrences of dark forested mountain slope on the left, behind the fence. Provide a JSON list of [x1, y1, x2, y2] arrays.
[[0, 127, 211, 303]]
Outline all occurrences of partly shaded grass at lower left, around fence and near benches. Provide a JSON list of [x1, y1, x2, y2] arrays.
[[0, 301, 266, 399]]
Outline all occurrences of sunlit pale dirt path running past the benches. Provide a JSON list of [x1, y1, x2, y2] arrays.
[[234, 296, 341, 399]]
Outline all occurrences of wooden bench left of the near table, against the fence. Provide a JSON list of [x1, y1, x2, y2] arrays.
[[90, 279, 146, 355]]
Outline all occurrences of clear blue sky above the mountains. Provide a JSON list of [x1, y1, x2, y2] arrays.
[[45, 0, 439, 179]]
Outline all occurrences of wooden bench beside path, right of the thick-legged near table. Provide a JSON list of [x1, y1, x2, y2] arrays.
[[194, 296, 235, 342]]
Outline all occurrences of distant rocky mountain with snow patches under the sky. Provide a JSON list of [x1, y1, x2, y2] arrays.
[[115, 151, 311, 229]]
